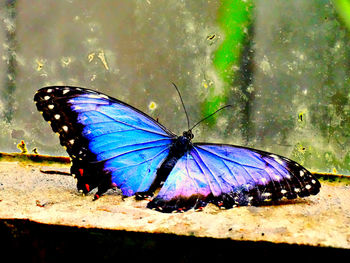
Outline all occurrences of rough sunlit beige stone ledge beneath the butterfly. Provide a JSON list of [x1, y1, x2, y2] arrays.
[[0, 162, 350, 248]]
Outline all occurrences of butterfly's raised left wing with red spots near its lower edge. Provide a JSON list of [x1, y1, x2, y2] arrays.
[[34, 86, 175, 197]]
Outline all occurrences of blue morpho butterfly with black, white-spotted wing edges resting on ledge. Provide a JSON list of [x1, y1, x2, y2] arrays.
[[34, 86, 321, 212]]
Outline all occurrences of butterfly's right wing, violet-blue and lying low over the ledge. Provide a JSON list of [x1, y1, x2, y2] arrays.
[[148, 143, 321, 212]]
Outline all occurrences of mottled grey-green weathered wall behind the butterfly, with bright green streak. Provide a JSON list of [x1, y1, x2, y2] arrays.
[[0, 0, 350, 174]]
